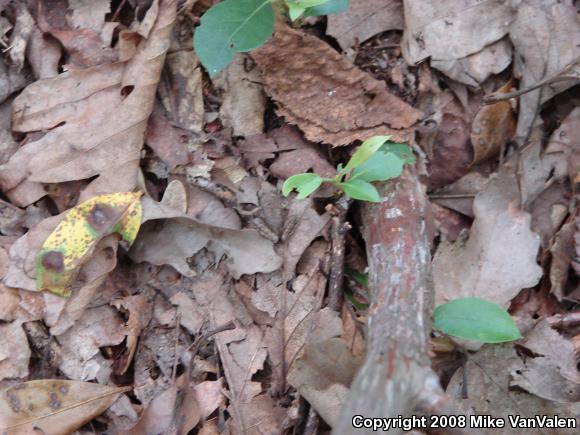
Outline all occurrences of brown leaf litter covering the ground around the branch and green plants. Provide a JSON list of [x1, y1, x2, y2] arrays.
[[0, 0, 580, 434]]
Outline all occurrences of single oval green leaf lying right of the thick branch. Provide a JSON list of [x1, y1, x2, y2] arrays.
[[433, 298, 522, 343]]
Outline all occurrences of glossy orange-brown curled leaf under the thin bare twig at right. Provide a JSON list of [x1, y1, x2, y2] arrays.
[[471, 82, 516, 165]]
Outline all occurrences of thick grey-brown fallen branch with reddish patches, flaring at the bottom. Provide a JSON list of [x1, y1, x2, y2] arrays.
[[333, 169, 475, 435]]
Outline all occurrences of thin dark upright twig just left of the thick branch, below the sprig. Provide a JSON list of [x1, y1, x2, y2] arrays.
[[328, 196, 350, 312]]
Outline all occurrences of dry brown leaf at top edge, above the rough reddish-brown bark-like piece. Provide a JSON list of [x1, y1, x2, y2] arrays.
[[326, 0, 403, 50]]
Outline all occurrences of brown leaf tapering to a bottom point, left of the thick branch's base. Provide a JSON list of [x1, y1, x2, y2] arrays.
[[288, 338, 360, 427]]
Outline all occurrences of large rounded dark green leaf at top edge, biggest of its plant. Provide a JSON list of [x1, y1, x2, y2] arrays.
[[193, 0, 274, 76]]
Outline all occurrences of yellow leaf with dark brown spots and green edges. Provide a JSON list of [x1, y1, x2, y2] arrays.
[[36, 192, 143, 297]]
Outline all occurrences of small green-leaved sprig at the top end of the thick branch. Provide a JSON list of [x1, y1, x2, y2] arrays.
[[282, 136, 415, 202]]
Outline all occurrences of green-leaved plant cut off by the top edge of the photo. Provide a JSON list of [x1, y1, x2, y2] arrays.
[[193, 0, 350, 76]]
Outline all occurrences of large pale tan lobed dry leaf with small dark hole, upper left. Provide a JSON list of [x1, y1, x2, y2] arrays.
[[0, 0, 176, 205]]
